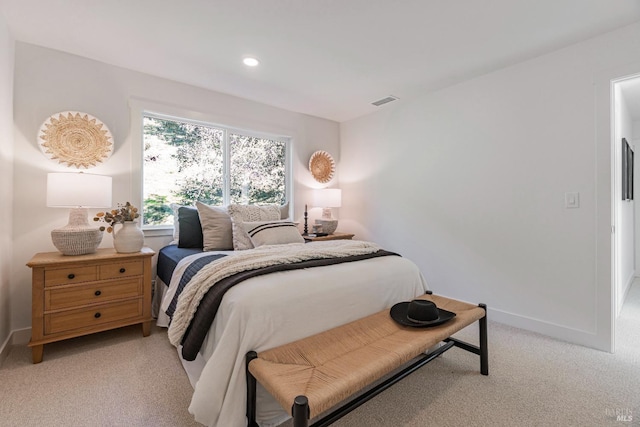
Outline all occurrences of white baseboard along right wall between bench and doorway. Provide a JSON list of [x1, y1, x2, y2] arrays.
[[487, 307, 612, 353]]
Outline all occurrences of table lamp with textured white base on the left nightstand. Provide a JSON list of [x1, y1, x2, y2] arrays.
[[47, 172, 111, 255]]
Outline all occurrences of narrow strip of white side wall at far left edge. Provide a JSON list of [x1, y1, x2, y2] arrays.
[[0, 15, 14, 363]]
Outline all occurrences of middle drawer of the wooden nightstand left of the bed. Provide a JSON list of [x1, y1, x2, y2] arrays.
[[44, 277, 142, 311]]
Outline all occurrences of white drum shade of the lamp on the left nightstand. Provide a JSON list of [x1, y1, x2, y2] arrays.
[[47, 172, 112, 208]]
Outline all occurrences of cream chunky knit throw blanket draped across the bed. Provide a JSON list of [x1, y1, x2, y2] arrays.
[[168, 240, 380, 347]]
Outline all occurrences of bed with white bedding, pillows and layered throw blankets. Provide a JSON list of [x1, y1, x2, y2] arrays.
[[156, 205, 427, 427]]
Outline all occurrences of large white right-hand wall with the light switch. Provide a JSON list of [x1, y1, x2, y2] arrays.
[[339, 21, 640, 350]]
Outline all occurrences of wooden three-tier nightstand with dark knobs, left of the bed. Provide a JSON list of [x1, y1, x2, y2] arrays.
[[27, 248, 155, 363]]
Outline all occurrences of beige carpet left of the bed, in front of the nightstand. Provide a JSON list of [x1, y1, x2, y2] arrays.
[[0, 326, 200, 427]]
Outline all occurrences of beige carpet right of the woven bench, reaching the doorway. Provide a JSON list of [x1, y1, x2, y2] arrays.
[[324, 281, 640, 427]]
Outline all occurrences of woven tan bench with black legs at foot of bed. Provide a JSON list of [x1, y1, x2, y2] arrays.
[[247, 293, 489, 427]]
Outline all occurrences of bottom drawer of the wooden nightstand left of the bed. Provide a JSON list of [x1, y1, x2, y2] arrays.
[[44, 299, 142, 334]]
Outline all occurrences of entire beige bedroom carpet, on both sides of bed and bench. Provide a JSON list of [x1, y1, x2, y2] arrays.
[[0, 283, 640, 427]]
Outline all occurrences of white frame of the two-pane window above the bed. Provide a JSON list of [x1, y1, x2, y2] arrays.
[[129, 98, 294, 232]]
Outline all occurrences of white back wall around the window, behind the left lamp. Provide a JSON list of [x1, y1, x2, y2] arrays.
[[11, 43, 339, 329]]
